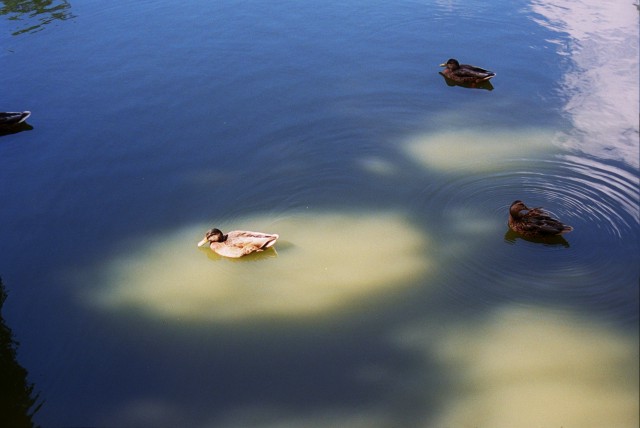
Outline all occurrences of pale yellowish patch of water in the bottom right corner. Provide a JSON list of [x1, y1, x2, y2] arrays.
[[401, 305, 639, 428]]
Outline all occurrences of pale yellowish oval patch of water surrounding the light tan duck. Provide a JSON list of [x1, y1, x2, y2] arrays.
[[77, 212, 434, 322]]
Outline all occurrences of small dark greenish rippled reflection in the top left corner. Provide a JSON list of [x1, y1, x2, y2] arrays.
[[0, 0, 75, 36]]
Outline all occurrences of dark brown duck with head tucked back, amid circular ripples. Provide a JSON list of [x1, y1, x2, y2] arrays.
[[509, 201, 573, 237]]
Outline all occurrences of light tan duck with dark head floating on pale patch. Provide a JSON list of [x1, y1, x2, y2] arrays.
[[198, 229, 279, 258]]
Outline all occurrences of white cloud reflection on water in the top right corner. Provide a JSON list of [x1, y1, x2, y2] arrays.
[[531, 0, 640, 168]]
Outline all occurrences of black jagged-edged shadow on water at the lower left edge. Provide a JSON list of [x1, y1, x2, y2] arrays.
[[0, 278, 43, 428]]
